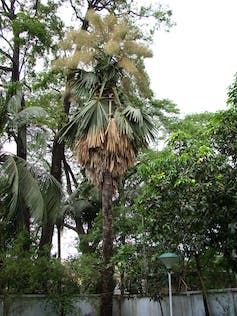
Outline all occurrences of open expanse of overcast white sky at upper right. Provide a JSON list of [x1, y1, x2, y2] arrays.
[[147, 0, 237, 114]]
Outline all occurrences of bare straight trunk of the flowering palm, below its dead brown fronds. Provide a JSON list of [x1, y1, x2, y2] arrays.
[[100, 171, 114, 316]]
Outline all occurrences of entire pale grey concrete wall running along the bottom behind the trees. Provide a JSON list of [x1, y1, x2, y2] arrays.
[[0, 289, 237, 316]]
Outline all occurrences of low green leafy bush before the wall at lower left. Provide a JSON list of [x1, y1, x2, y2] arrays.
[[0, 234, 80, 315]]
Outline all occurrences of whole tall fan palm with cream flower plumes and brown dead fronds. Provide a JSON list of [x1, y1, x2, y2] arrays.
[[56, 11, 154, 316]]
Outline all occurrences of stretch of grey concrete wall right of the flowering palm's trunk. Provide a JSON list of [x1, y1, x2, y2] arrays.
[[114, 289, 237, 316]]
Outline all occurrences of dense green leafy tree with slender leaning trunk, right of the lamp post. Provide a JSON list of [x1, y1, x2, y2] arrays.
[[133, 114, 236, 315]]
